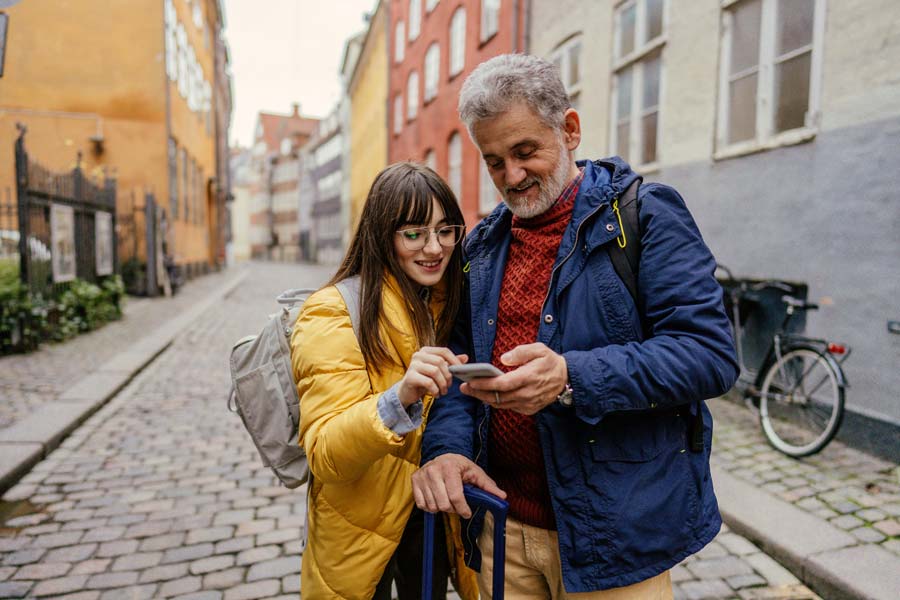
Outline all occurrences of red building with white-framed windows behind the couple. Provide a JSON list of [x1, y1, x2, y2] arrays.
[[388, 0, 527, 227]]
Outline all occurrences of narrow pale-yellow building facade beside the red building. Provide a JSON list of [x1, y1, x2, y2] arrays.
[[350, 1, 388, 231]]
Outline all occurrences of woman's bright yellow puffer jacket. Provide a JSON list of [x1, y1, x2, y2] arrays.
[[291, 278, 474, 600]]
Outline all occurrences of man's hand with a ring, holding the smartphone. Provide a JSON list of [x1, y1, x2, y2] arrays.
[[459, 343, 569, 415]]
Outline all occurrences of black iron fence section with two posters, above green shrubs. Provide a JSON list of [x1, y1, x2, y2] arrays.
[[14, 125, 118, 295]]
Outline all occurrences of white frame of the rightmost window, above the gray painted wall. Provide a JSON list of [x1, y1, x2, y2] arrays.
[[713, 0, 827, 160]]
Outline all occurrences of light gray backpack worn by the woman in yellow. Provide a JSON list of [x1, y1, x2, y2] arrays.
[[228, 277, 360, 488]]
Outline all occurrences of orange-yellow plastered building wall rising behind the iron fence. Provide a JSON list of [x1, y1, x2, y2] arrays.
[[0, 0, 216, 263]]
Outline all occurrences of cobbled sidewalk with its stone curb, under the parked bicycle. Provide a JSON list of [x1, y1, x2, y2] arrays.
[[710, 399, 900, 599]]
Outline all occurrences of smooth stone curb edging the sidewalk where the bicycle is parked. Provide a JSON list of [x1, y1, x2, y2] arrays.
[[712, 466, 900, 600]]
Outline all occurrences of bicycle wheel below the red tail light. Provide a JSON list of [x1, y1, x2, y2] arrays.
[[759, 345, 844, 458]]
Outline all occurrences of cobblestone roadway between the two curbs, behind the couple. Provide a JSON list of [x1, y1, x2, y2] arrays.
[[0, 264, 880, 600]]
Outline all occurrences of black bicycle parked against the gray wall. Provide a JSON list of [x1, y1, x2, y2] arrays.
[[717, 265, 851, 458]]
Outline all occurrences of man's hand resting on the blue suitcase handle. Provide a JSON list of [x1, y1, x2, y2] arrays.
[[413, 454, 506, 519]]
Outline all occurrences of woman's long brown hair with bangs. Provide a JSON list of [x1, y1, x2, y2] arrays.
[[328, 162, 465, 371]]
